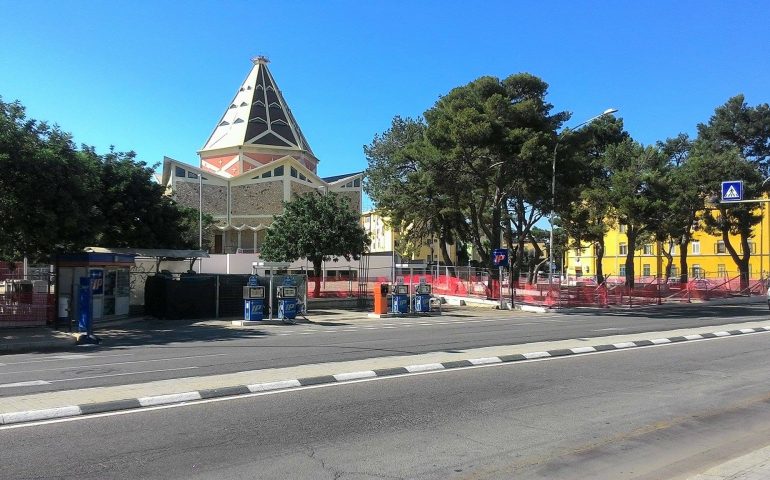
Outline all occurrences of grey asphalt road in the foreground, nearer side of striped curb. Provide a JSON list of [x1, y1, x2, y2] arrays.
[[0, 333, 770, 480]]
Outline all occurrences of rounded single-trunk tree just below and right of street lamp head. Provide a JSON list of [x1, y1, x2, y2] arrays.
[[605, 139, 670, 288]]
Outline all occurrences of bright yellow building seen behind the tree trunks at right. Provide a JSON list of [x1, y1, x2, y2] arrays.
[[564, 212, 770, 279]]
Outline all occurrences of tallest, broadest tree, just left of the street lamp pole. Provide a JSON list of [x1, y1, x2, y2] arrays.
[[425, 73, 567, 275]]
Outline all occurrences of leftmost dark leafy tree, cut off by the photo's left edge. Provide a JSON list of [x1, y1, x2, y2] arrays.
[[0, 98, 100, 262]]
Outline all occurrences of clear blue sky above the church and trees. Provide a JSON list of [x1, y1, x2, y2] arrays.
[[0, 0, 770, 209]]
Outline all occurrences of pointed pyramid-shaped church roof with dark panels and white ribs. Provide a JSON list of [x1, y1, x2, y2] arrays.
[[198, 56, 317, 161]]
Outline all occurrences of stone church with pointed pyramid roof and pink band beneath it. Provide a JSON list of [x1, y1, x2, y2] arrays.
[[161, 57, 363, 254]]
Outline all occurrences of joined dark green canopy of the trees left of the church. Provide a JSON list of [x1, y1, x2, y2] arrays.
[[0, 98, 210, 261]]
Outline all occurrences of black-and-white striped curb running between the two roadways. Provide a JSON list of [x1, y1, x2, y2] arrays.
[[0, 325, 770, 425]]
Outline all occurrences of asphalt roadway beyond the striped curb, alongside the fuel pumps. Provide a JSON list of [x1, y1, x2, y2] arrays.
[[0, 299, 768, 397]]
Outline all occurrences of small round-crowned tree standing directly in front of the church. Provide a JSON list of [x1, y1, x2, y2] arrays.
[[261, 192, 369, 296]]
